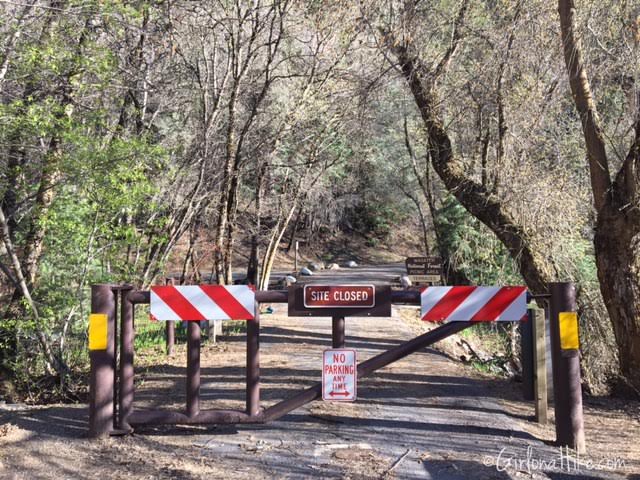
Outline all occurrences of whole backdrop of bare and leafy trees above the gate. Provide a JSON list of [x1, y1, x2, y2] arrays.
[[0, 0, 640, 398]]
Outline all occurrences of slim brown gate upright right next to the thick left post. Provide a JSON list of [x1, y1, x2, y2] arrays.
[[117, 287, 135, 431]]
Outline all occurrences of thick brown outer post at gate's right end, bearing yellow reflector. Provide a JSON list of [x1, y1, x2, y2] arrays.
[[549, 282, 586, 453]]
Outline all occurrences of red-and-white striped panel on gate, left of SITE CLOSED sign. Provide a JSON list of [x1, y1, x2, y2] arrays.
[[150, 285, 256, 320]]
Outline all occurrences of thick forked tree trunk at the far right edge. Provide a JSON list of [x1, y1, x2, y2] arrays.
[[558, 0, 640, 391]]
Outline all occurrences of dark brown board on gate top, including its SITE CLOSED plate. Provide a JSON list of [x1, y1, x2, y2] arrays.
[[289, 284, 391, 317]]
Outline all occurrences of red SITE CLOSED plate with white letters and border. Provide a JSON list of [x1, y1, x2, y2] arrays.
[[304, 285, 376, 308]]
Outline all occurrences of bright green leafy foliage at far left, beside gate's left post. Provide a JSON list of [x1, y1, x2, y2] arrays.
[[0, 25, 170, 383]]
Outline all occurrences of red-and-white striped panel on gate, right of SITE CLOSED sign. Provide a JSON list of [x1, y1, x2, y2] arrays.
[[420, 287, 527, 322]]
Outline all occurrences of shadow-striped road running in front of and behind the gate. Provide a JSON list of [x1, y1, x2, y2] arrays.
[[0, 268, 638, 480]]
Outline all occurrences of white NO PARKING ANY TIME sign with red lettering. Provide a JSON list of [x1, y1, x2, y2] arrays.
[[322, 348, 358, 402]]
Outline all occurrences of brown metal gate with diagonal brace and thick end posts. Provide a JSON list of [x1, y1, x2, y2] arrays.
[[89, 283, 584, 447]]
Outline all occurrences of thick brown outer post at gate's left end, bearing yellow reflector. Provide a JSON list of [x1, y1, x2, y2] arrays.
[[89, 285, 116, 438]]
